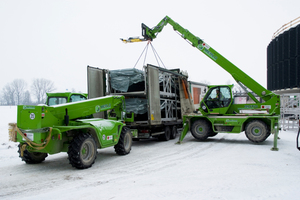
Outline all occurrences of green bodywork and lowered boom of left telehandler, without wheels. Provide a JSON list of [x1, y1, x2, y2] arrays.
[[17, 96, 125, 154]]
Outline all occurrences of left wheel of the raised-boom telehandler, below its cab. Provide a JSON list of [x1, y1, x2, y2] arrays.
[[191, 119, 212, 140]]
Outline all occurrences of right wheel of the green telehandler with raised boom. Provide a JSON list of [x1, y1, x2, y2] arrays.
[[245, 120, 270, 143]]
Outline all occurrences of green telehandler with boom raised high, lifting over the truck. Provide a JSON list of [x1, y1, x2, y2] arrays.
[[121, 16, 280, 150]]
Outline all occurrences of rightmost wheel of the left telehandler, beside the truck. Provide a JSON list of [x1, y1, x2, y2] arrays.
[[114, 127, 132, 155]]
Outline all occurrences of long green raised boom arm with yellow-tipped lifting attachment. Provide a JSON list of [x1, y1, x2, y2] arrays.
[[121, 16, 273, 103]]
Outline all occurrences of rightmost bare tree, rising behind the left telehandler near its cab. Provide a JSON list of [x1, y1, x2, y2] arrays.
[[31, 78, 55, 104]]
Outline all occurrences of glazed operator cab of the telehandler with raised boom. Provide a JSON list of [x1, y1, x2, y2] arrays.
[[199, 85, 233, 114]]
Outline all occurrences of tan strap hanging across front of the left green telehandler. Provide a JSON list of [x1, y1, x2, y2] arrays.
[[10, 124, 52, 156]]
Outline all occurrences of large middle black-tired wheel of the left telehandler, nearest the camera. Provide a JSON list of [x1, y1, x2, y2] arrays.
[[68, 133, 97, 169]]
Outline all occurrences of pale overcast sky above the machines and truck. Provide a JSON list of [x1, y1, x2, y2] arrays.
[[0, 0, 300, 92]]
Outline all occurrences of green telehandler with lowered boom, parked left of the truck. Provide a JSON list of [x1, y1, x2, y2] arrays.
[[9, 94, 132, 169]]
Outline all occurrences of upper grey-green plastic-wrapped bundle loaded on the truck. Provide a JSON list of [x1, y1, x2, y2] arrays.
[[110, 68, 144, 92]]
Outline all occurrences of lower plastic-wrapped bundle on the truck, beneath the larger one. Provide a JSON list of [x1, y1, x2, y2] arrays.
[[125, 98, 147, 114]]
